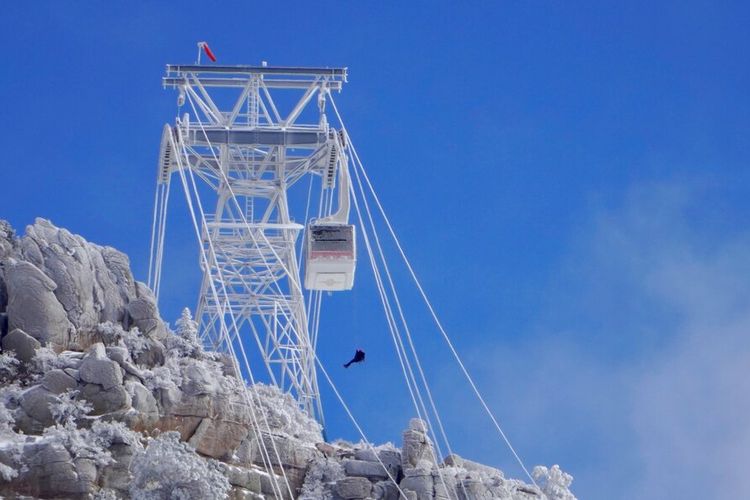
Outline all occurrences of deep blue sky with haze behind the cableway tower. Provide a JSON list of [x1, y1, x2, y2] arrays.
[[0, 1, 750, 499]]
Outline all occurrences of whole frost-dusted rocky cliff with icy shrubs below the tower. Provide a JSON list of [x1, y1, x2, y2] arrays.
[[0, 219, 574, 500]]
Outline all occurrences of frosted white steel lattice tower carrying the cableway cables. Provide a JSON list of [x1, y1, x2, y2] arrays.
[[155, 65, 346, 422]]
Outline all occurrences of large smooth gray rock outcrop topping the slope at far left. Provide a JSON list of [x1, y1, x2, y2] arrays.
[[0, 219, 168, 351]]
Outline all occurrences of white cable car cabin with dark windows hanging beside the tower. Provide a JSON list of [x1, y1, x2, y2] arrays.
[[305, 223, 357, 291]]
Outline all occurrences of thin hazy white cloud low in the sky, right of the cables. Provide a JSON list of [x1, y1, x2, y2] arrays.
[[444, 184, 750, 500]]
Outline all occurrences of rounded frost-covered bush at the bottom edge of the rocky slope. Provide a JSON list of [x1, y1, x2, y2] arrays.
[[130, 432, 230, 500]]
